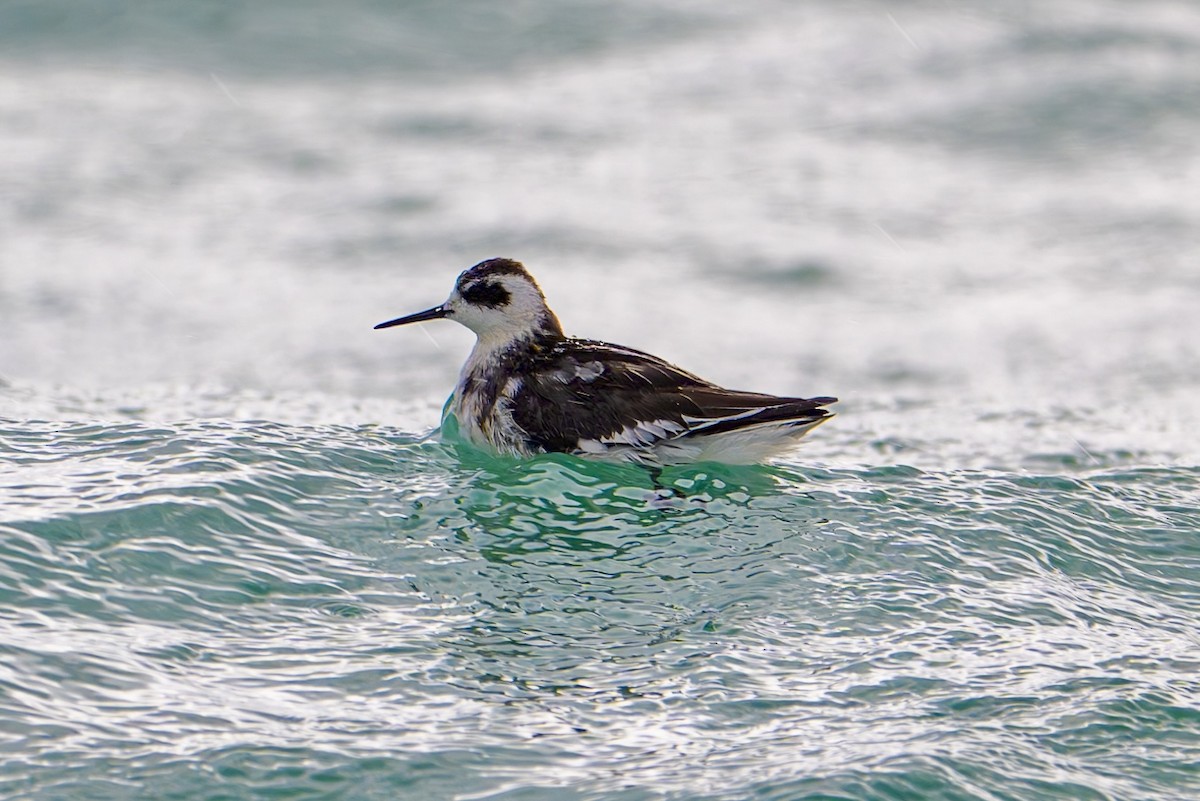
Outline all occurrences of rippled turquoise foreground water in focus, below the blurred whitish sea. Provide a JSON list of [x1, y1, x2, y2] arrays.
[[0, 412, 1200, 799]]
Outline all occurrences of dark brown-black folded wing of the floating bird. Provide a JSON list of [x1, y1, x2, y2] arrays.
[[512, 339, 836, 452]]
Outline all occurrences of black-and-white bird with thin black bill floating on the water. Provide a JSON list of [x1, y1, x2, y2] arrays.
[[374, 259, 836, 466]]
